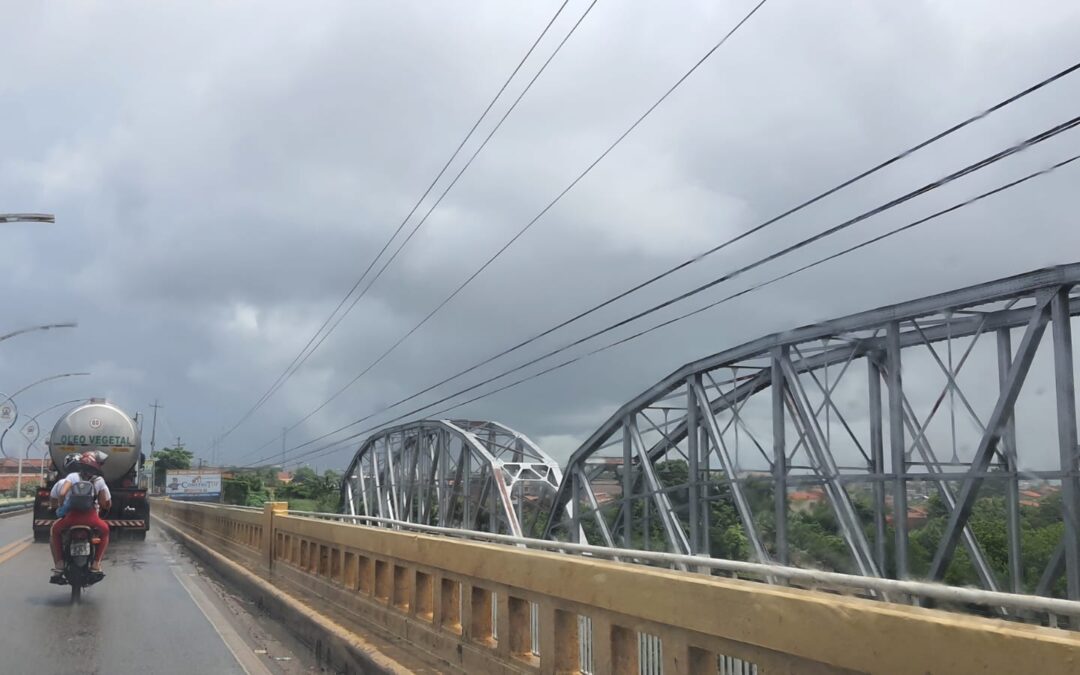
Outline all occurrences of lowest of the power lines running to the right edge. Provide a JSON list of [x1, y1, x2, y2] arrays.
[[261, 154, 1080, 468]]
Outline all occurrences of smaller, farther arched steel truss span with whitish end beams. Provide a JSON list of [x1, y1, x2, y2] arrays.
[[341, 420, 562, 537]]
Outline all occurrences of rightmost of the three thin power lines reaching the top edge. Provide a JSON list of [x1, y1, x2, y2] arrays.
[[243, 0, 768, 457]]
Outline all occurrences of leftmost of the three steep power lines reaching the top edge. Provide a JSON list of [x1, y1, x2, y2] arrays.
[[213, 0, 578, 441]]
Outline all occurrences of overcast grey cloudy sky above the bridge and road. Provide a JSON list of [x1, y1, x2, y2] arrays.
[[0, 0, 1080, 468]]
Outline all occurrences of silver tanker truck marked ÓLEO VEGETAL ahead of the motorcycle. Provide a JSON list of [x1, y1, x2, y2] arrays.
[[33, 399, 150, 541]]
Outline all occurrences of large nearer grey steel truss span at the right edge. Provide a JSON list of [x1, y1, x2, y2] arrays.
[[544, 264, 1080, 599]]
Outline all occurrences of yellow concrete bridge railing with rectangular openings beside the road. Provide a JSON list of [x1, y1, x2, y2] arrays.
[[157, 501, 1080, 674]]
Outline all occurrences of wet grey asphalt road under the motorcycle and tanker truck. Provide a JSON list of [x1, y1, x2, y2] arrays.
[[0, 515, 247, 675]]
